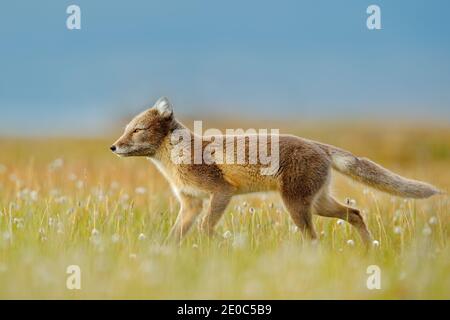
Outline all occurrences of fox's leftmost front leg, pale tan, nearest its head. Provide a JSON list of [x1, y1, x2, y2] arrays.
[[169, 194, 203, 243]]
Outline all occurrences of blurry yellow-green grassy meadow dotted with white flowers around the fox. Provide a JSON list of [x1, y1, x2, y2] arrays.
[[0, 122, 450, 299]]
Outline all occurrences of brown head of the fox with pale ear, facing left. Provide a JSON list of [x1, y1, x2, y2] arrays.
[[110, 97, 174, 157]]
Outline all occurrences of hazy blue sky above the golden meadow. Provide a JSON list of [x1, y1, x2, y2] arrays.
[[0, 0, 450, 135]]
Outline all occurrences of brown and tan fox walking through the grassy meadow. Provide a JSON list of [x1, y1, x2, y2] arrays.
[[110, 97, 443, 245]]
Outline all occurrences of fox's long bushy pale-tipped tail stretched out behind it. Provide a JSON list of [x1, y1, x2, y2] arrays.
[[317, 143, 443, 198]]
